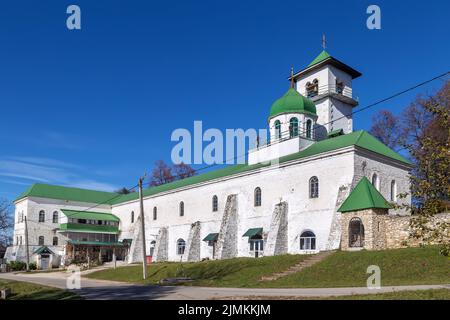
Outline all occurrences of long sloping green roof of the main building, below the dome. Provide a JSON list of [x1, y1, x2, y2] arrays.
[[112, 130, 411, 205]]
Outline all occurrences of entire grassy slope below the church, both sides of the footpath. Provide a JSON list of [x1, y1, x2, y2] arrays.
[[87, 247, 450, 288]]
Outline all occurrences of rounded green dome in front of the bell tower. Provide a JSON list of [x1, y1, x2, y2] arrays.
[[269, 88, 316, 119]]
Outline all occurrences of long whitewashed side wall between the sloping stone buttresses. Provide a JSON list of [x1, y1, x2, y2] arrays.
[[112, 148, 354, 261]]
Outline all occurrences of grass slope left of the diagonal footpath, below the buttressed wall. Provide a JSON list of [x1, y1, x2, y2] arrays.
[[86, 255, 307, 287]]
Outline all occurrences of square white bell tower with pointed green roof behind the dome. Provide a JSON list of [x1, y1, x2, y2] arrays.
[[289, 47, 361, 140]]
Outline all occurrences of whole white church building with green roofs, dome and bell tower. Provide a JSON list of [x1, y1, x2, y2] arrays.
[[6, 51, 411, 268]]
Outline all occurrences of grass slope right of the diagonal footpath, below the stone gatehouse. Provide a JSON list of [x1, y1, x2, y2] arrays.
[[261, 247, 450, 288]]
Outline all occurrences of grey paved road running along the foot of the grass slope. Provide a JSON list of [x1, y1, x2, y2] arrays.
[[0, 272, 450, 300]]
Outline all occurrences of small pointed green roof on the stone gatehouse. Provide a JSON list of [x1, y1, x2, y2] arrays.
[[338, 177, 391, 212]]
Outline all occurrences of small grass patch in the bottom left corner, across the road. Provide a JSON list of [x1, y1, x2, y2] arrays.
[[0, 279, 81, 300]]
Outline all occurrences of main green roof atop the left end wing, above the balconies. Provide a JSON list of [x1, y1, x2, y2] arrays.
[[15, 183, 119, 204]]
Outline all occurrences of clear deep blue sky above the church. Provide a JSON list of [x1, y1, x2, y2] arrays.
[[0, 0, 450, 199]]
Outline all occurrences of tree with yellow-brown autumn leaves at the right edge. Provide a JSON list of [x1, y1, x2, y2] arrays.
[[405, 82, 450, 255]]
